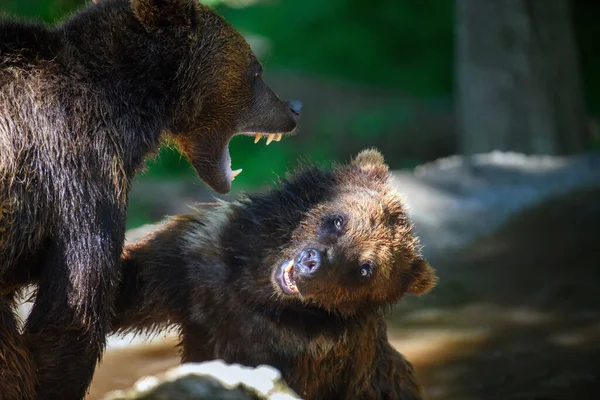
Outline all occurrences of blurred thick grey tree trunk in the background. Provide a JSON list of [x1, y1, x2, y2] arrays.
[[456, 0, 587, 155]]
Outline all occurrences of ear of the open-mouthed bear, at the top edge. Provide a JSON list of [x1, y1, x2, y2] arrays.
[[131, 0, 198, 30]]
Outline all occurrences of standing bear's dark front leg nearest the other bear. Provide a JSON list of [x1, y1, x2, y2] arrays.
[[25, 213, 124, 400]]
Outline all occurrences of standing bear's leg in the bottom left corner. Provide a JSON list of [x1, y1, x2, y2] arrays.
[[0, 293, 36, 400]]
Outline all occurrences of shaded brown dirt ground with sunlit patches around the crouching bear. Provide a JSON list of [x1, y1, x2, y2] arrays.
[[88, 190, 600, 400]]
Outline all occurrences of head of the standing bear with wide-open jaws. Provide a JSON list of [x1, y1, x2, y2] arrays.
[[91, 0, 302, 193]]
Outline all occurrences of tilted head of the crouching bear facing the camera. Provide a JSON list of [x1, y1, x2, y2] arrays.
[[223, 150, 437, 315]]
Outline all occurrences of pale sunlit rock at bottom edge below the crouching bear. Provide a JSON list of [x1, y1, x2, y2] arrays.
[[103, 360, 300, 400]]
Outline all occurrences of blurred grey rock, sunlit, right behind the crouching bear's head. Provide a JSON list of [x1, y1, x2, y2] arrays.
[[394, 152, 600, 256]]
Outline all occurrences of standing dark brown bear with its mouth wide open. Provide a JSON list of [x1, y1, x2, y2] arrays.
[[0, 0, 300, 399]]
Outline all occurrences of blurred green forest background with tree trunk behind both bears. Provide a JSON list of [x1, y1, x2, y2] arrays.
[[0, 0, 600, 227]]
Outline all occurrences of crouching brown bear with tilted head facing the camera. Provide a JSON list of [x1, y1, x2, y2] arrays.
[[113, 150, 436, 400]]
